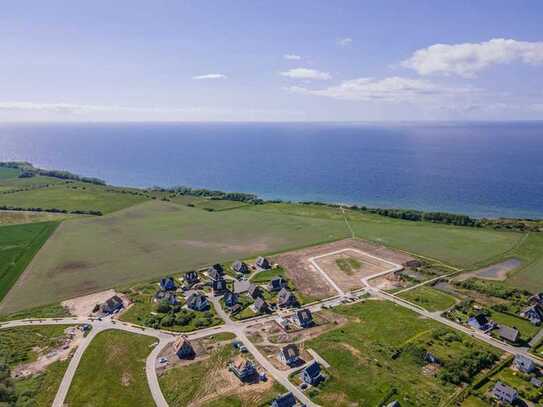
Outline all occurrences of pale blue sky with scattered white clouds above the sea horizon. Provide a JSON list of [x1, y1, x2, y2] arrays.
[[0, 0, 543, 121]]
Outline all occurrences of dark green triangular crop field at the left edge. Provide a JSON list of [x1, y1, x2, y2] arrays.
[[0, 222, 58, 306]]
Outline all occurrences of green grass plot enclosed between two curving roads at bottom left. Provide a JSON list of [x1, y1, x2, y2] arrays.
[[66, 331, 156, 407]]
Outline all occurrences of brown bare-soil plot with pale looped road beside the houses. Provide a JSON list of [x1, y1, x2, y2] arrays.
[[273, 239, 414, 299]]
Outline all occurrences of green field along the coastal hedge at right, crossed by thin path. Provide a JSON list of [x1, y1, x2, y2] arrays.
[[251, 204, 524, 267]]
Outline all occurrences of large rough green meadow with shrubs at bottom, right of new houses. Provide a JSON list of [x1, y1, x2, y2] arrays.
[[305, 301, 498, 407]]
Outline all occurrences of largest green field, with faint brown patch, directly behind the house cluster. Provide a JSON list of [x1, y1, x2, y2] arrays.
[[0, 200, 348, 313]]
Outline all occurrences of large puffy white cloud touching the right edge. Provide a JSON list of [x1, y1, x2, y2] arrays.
[[402, 38, 543, 78]]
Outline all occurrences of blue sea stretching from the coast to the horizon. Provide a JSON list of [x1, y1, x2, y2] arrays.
[[0, 122, 543, 218]]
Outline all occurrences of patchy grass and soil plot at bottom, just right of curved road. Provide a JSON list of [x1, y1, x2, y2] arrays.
[[159, 344, 285, 407]]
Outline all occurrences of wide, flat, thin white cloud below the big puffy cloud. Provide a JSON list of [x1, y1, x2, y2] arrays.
[[287, 76, 477, 102]]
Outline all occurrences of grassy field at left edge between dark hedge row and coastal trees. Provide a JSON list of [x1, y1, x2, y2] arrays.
[[0, 181, 147, 213]]
